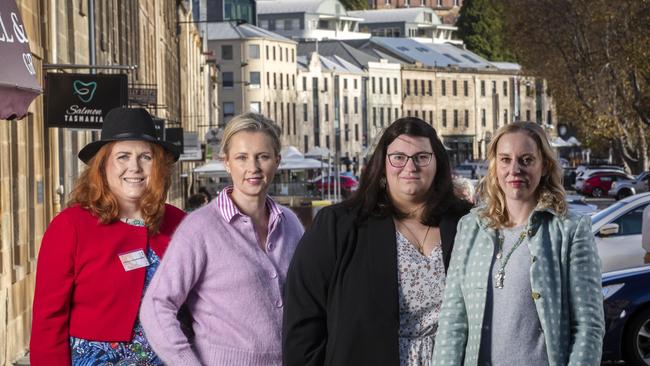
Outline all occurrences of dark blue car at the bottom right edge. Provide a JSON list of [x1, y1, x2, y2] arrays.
[[603, 266, 650, 366]]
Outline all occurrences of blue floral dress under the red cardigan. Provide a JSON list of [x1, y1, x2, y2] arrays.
[[70, 222, 164, 366]]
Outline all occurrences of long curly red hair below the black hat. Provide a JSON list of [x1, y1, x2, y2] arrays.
[[68, 142, 174, 233]]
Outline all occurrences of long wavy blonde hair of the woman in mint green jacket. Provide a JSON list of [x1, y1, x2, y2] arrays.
[[479, 122, 567, 229]]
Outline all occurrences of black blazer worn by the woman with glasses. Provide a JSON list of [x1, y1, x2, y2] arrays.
[[282, 205, 462, 366]]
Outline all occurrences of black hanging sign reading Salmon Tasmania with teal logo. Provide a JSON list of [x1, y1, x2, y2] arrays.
[[45, 73, 128, 129]]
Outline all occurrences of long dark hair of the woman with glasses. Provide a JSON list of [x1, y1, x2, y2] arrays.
[[344, 117, 470, 226]]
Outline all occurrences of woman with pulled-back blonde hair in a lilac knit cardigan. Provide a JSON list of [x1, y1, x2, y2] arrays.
[[140, 113, 303, 366]]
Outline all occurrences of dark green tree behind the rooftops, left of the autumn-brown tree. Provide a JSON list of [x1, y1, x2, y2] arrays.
[[456, 0, 514, 61]]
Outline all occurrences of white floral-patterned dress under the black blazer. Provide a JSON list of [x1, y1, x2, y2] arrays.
[[397, 231, 445, 366]]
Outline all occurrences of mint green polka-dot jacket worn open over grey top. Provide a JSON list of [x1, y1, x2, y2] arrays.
[[433, 208, 605, 366]]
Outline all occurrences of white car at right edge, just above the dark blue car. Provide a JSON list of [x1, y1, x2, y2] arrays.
[[591, 193, 650, 273]]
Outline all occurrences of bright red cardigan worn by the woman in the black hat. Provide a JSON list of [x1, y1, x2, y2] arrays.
[[30, 205, 185, 366]]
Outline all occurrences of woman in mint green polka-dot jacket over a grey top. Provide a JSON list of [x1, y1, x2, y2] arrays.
[[433, 122, 604, 366]]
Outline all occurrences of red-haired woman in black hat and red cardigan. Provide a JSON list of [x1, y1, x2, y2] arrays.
[[30, 108, 185, 366]]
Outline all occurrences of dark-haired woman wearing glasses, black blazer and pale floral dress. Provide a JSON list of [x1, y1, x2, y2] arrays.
[[283, 117, 469, 366]]
